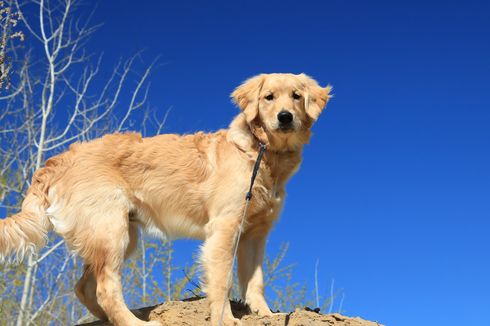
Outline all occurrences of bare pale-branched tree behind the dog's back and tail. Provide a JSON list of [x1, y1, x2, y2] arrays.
[[0, 0, 166, 325]]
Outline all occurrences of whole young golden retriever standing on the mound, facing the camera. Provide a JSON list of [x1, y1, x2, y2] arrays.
[[0, 74, 330, 326]]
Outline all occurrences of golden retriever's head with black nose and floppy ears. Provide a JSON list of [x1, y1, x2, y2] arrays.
[[231, 74, 331, 150]]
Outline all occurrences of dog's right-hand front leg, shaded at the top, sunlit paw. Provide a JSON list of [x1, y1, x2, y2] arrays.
[[238, 234, 272, 316]]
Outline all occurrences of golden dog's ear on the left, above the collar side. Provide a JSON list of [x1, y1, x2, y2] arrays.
[[231, 74, 265, 123]]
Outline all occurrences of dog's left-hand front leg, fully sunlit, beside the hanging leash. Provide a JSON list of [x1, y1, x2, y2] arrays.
[[201, 217, 241, 326]]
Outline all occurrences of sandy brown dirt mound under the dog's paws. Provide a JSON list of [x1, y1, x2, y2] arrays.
[[78, 298, 381, 326]]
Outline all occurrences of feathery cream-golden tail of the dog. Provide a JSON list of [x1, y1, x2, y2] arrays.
[[0, 161, 57, 262]]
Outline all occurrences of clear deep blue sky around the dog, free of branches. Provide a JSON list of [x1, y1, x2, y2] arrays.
[[13, 0, 490, 326]]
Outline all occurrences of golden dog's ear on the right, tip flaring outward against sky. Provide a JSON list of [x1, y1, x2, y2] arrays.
[[299, 74, 332, 121]]
